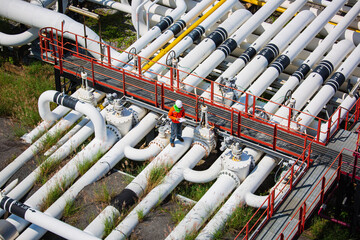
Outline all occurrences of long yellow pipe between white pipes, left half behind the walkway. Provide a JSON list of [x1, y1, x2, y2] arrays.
[[142, 0, 226, 71]]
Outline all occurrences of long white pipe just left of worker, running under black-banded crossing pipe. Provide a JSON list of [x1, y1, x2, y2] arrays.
[[16, 112, 158, 239]]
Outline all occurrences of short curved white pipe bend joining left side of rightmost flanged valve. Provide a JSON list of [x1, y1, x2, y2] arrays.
[[184, 158, 222, 183]]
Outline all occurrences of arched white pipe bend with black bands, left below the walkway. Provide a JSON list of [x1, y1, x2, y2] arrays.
[[38, 90, 107, 141]]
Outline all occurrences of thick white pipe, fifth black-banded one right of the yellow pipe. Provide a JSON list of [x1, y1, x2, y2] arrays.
[[235, 10, 315, 91]]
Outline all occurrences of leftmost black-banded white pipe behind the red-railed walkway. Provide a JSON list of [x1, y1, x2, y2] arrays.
[[117, 0, 186, 67]]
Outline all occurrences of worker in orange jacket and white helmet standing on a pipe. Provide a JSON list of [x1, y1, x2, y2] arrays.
[[168, 100, 185, 147]]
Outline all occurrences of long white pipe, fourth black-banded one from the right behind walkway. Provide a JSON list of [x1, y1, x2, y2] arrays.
[[233, 0, 345, 110]]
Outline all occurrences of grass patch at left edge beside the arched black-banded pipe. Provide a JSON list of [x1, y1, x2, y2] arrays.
[[0, 61, 55, 129]]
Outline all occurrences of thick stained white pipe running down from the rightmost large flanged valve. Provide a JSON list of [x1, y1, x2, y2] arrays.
[[166, 171, 240, 240]]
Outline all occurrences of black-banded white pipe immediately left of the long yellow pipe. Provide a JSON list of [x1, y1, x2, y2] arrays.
[[125, 0, 215, 70]]
